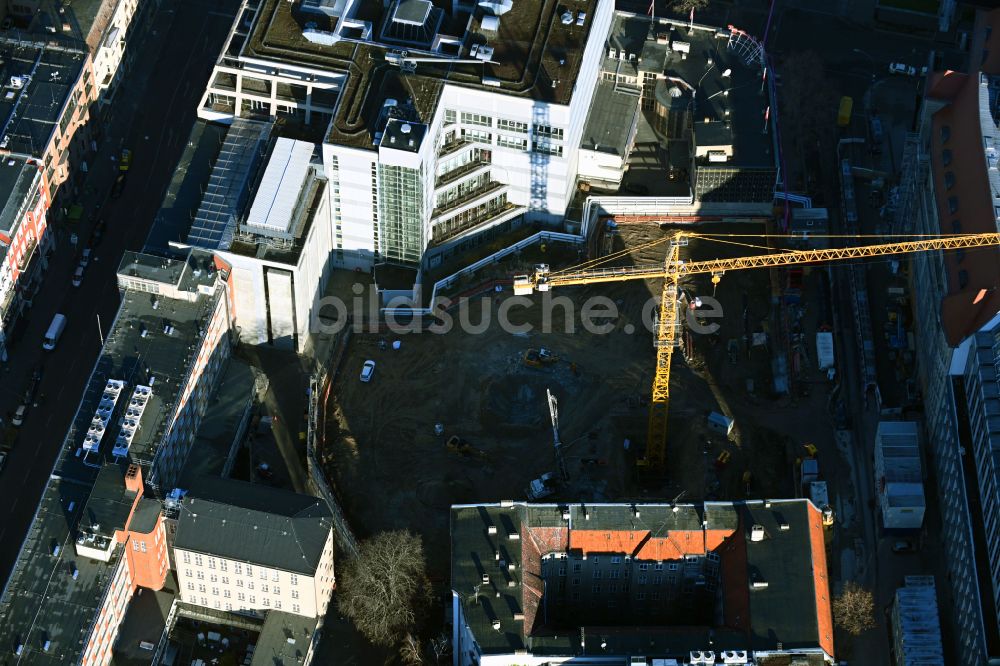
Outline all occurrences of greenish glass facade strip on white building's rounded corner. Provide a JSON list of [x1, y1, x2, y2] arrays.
[[378, 164, 424, 264]]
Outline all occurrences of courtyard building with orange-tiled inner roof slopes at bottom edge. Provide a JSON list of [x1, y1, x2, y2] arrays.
[[451, 499, 835, 666]]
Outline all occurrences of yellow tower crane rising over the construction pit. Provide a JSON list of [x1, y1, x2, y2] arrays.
[[514, 232, 1000, 472]]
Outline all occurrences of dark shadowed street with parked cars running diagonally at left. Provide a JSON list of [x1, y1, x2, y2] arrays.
[[0, 0, 237, 581]]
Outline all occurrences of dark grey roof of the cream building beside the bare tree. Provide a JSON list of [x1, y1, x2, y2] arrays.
[[174, 477, 333, 576]]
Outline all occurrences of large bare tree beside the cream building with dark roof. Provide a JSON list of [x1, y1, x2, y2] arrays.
[[337, 530, 430, 647]]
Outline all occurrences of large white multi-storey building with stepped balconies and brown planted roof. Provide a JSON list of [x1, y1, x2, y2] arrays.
[[199, 0, 613, 269]]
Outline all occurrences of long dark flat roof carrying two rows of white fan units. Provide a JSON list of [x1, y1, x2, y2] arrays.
[[0, 250, 228, 664]]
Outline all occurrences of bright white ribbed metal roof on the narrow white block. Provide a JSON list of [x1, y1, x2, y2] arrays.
[[245, 137, 313, 239]]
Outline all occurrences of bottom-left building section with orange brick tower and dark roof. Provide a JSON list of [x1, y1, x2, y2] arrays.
[[0, 461, 169, 666]]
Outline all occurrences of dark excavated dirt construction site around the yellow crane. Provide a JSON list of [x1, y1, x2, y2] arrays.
[[321, 223, 834, 577]]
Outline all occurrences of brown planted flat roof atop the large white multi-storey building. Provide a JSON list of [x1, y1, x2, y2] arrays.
[[231, 0, 603, 149]]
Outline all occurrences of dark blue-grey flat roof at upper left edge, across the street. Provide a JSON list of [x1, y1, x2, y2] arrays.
[[0, 39, 86, 158]]
